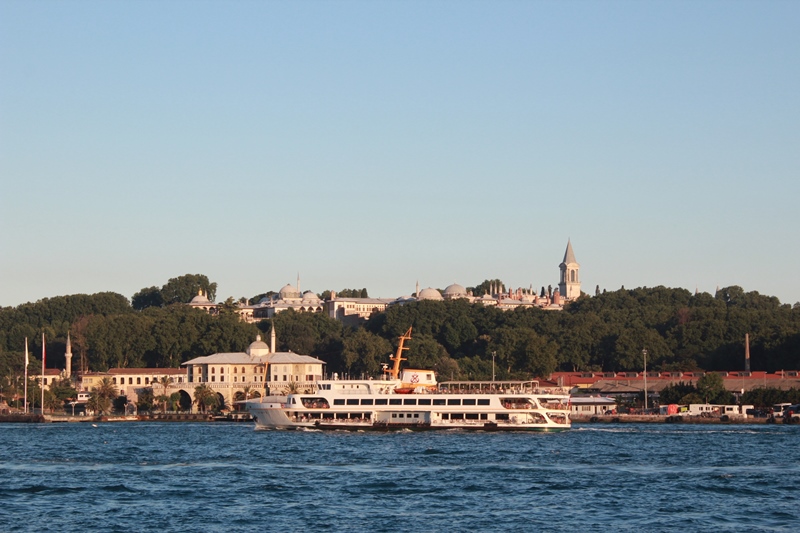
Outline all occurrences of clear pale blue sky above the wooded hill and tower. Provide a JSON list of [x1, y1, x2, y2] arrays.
[[0, 0, 800, 306]]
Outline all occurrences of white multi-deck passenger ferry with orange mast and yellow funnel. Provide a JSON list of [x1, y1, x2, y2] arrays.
[[246, 328, 570, 431]]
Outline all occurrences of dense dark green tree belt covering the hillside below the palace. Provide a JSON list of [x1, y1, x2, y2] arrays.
[[0, 275, 800, 386]]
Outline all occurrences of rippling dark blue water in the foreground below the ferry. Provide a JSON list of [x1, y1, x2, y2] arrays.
[[0, 423, 800, 533]]
